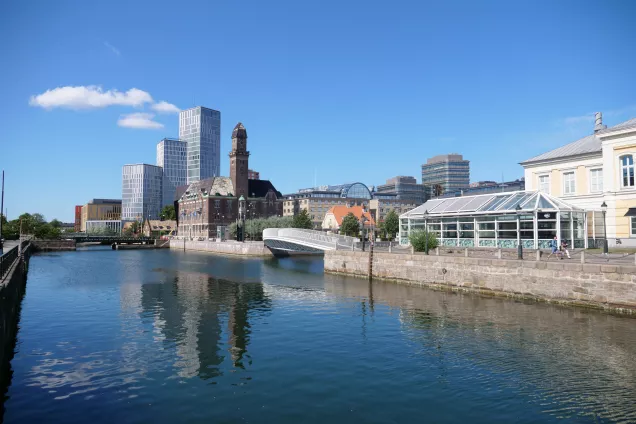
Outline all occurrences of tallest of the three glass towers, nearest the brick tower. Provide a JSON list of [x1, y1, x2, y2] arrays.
[[179, 106, 221, 184]]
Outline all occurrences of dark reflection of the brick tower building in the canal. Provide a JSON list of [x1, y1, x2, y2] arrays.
[[142, 271, 270, 379]]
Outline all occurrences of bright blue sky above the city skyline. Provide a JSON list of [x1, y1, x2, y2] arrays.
[[0, 0, 636, 221]]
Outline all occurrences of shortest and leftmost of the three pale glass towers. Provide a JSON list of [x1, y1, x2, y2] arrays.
[[121, 163, 163, 221]]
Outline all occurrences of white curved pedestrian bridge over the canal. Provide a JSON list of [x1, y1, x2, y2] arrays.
[[263, 228, 358, 253]]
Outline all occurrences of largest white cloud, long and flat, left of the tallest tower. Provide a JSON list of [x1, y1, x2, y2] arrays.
[[29, 85, 152, 109]]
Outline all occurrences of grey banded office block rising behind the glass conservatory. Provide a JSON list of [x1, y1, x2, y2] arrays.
[[422, 153, 470, 198]]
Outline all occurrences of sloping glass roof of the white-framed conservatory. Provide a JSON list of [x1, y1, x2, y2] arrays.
[[400, 191, 584, 218]]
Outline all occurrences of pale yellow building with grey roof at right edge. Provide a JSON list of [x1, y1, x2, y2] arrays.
[[521, 113, 636, 247]]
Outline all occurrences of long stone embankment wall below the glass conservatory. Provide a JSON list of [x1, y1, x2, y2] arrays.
[[324, 251, 636, 313]]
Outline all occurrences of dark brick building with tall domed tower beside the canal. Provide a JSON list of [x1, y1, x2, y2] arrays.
[[174, 122, 283, 239]]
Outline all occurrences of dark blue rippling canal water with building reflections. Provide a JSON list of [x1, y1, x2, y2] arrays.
[[3, 249, 636, 423]]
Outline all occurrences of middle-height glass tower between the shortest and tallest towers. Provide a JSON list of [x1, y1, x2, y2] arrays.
[[157, 138, 187, 207]]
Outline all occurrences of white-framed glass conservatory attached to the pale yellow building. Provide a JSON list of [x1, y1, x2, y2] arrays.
[[400, 191, 588, 249]]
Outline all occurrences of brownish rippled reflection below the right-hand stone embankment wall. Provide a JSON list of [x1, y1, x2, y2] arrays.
[[325, 277, 636, 422]]
